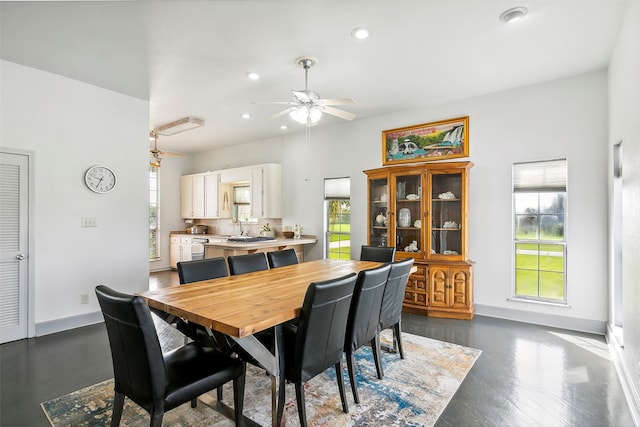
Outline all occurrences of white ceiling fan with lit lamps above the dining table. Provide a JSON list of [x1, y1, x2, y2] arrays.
[[270, 57, 356, 126]]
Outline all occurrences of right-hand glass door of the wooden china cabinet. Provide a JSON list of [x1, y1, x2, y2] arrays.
[[428, 172, 465, 258]]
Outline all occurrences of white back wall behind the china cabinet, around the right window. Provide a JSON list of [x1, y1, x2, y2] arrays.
[[186, 71, 608, 333]]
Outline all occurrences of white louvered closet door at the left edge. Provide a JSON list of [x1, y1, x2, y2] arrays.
[[0, 152, 29, 343]]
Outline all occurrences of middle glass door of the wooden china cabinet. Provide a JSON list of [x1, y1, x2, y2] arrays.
[[389, 173, 424, 256]]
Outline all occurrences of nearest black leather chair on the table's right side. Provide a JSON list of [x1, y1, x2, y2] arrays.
[[276, 273, 356, 427]]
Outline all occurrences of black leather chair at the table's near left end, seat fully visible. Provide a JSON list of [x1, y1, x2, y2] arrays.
[[95, 285, 245, 427]]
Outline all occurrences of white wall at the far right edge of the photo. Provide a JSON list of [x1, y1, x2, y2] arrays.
[[607, 2, 640, 422]]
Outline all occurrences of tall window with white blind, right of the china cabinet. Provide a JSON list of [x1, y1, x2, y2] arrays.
[[513, 159, 567, 304]]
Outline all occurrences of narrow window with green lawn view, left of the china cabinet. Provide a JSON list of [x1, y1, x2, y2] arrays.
[[324, 178, 351, 259]]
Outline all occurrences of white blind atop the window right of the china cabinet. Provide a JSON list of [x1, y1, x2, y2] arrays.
[[513, 159, 567, 192]]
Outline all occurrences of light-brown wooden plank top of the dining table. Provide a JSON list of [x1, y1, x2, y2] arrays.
[[137, 259, 382, 338]]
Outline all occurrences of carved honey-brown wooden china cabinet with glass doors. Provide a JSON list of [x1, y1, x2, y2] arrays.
[[364, 162, 475, 319]]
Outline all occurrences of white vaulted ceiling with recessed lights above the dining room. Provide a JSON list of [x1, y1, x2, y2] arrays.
[[0, 0, 625, 153]]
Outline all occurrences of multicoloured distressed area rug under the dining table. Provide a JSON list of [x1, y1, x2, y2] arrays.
[[41, 333, 481, 427]]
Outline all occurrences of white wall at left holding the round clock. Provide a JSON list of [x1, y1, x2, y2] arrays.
[[0, 61, 149, 333]]
